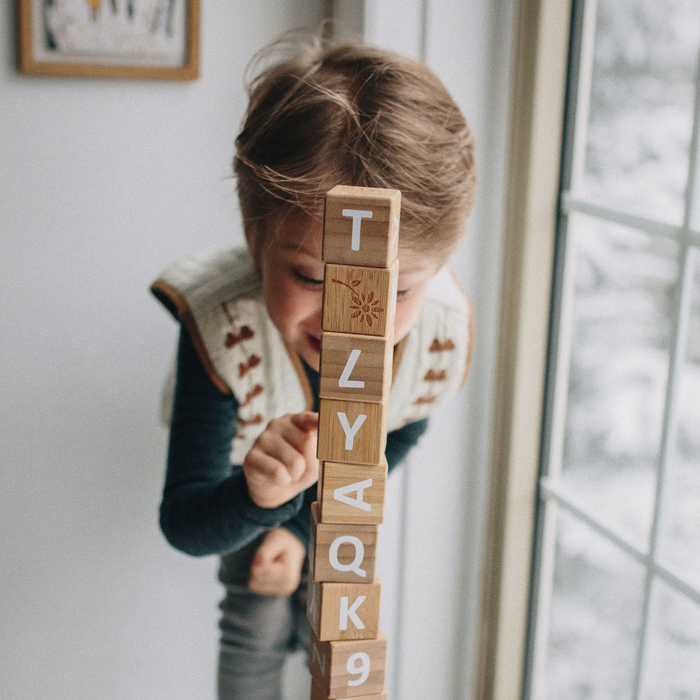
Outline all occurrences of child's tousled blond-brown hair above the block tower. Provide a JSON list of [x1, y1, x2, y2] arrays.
[[234, 33, 476, 259]]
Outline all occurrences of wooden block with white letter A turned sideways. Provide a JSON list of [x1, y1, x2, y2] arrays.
[[318, 457, 387, 525]]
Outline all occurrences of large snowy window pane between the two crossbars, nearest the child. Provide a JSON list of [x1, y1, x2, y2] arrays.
[[561, 215, 678, 548]]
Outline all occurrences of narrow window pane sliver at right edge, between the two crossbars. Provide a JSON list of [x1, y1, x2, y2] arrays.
[[659, 253, 700, 588]]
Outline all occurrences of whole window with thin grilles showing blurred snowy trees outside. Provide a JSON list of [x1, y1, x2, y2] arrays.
[[530, 0, 700, 700]]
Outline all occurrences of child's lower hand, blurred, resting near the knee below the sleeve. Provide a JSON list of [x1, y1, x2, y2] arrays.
[[248, 527, 306, 595]]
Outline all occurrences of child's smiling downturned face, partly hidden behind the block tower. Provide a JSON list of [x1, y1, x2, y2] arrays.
[[253, 214, 439, 371]]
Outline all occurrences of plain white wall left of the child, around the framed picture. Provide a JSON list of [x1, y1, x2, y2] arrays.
[[0, 0, 322, 700]]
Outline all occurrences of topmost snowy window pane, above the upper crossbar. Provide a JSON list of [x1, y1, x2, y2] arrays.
[[582, 0, 700, 224]]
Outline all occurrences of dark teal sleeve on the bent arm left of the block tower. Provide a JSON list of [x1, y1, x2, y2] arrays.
[[160, 328, 308, 556]]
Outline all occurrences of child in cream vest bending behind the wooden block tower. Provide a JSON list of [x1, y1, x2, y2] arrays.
[[152, 34, 476, 700]]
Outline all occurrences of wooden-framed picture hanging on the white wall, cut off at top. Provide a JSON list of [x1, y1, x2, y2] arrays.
[[18, 0, 199, 80]]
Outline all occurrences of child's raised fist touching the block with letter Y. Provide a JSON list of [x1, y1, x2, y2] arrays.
[[243, 411, 318, 508]]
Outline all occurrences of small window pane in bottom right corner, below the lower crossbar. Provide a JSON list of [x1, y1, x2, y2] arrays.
[[642, 582, 700, 700]]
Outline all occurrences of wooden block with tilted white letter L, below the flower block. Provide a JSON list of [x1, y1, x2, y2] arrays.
[[318, 333, 394, 403]]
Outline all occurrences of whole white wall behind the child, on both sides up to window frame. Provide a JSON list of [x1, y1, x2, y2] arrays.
[[0, 0, 511, 700]]
